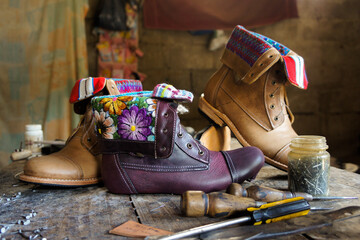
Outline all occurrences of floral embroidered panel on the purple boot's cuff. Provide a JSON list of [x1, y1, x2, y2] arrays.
[[91, 92, 157, 141]]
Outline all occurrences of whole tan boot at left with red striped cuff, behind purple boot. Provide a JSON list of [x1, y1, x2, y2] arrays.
[[19, 78, 142, 186]]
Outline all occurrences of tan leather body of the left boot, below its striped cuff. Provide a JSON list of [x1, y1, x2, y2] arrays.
[[19, 106, 101, 186]]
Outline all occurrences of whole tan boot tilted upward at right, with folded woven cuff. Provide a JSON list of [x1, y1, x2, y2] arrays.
[[199, 26, 307, 170]]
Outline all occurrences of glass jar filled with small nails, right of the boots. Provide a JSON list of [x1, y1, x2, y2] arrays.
[[288, 136, 330, 196]]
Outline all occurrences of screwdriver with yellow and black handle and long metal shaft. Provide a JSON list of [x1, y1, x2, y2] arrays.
[[159, 197, 310, 240]]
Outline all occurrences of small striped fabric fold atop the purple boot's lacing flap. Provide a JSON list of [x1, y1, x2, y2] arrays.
[[152, 83, 194, 102]]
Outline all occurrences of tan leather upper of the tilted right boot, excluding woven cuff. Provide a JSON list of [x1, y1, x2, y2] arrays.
[[204, 40, 297, 169]]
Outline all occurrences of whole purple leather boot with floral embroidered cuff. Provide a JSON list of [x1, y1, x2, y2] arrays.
[[92, 84, 264, 194]]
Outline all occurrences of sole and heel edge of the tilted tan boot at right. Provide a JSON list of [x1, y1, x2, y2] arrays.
[[199, 95, 287, 171]]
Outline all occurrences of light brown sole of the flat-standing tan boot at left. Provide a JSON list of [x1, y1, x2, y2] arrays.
[[19, 173, 100, 187]]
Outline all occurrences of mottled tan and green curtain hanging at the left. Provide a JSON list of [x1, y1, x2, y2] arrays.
[[0, 0, 89, 168]]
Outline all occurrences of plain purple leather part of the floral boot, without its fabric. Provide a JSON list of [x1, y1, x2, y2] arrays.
[[99, 100, 264, 194]]
